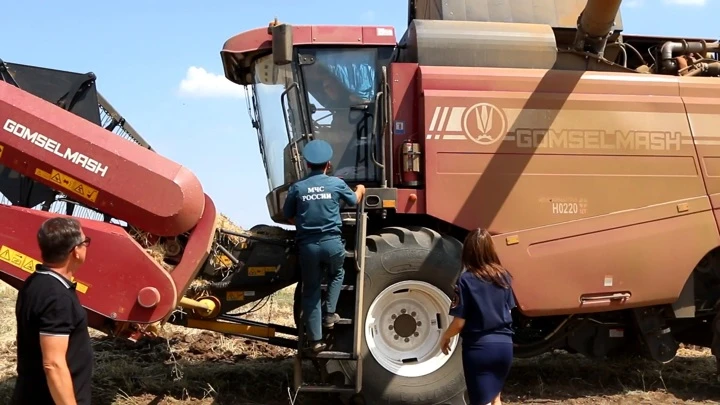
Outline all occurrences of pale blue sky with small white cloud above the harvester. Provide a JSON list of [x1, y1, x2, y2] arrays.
[[0, 0, 720, 227]]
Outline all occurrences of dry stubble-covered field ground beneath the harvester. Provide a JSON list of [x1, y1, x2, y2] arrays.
[[0, 283, 720, 405]]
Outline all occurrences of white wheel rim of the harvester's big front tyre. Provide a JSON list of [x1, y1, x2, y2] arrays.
[[365, 280, 458, 377]]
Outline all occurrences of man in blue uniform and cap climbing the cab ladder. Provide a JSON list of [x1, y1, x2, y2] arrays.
[[283, 140, 365, 353]]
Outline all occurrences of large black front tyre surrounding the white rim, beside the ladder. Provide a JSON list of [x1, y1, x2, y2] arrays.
[[332, 227, 466, 405]]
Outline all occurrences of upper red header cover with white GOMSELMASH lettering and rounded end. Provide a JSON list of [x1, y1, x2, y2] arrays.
[[0, 82, 205, 236]]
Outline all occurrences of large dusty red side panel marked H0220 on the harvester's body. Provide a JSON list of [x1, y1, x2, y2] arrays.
[[408, 67, 720, 316]]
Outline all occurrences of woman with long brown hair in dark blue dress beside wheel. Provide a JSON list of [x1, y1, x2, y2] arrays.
[[441, 229, 515, 405]]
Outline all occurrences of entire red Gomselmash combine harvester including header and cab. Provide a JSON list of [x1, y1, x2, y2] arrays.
[[0, 0, 720, 405]]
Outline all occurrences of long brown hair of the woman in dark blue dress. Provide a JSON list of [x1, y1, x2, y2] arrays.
[[462, 228, 512, 288]]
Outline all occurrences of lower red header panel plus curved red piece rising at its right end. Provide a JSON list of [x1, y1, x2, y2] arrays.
[[0, 192, 216, 328]]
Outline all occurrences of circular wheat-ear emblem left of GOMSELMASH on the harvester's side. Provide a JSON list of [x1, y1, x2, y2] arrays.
[[463, 103, 507, 145]]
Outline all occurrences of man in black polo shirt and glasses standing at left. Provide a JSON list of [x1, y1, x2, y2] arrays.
[[11, 218, 93, 405]]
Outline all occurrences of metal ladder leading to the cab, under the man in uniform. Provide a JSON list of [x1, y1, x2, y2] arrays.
[[293, 198, 367, 394]]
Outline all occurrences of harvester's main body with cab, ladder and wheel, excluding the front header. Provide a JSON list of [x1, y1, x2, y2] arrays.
[[220, 0, 720, 404]]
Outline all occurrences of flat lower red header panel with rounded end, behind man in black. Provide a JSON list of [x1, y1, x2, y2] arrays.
[[0, 206, 177, 326]]
